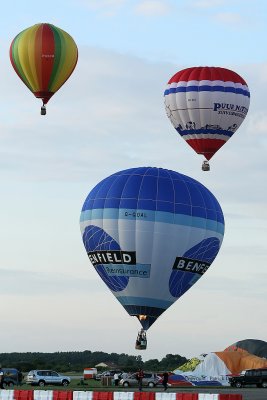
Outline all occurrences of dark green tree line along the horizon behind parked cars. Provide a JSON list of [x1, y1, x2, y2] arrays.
[[0, 350, 188, 372]]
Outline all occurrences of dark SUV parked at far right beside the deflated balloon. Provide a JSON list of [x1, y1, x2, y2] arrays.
[[228, 368, 267, 388]]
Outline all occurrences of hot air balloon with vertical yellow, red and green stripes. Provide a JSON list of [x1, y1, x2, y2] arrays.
[[10, 24, 78, 115]]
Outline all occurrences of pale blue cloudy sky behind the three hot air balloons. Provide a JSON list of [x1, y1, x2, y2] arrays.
[[0, 0, 267, 366]]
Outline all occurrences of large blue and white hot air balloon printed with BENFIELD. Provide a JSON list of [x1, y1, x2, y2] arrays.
[[80, 167, 224, 348]]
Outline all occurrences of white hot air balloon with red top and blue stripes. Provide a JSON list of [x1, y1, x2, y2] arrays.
[[164, 67, 250, 171]]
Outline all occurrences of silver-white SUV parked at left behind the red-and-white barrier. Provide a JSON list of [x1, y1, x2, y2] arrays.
[[26, 369, 71, 386]]
